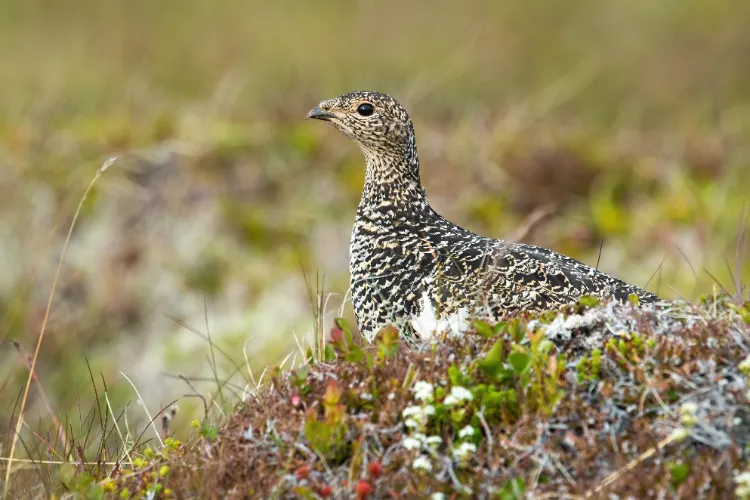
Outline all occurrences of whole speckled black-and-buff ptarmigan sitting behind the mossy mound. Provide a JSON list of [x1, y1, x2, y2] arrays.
[[306, 91, 661, 344]]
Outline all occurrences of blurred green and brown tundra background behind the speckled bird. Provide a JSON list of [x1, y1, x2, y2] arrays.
[[0, 0, 750, 446]]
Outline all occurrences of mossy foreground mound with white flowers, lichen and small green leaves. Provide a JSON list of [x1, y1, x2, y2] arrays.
[[101, 299, 750, 499]]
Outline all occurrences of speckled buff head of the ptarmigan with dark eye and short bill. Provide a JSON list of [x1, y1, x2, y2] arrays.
[[307, 91, 416, 160]]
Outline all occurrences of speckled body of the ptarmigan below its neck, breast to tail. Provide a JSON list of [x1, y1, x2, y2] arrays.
[[350, 194, 658, 338]]
